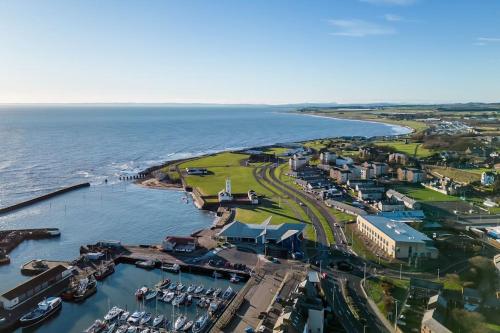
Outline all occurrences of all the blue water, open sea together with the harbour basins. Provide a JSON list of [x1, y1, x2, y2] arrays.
[[0, 106, 407, 332]]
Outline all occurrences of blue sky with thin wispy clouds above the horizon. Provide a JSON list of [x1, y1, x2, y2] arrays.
[[0, 0, 500, 104]]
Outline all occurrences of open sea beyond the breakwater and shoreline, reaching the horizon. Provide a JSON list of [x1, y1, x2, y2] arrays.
[[0, 106, 407, 206]]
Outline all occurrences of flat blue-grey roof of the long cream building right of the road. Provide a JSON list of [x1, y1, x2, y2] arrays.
[[361, 215, 430, 243]]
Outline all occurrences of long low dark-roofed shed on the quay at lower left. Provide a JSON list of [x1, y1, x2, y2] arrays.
[[0, 265, 73, 310]]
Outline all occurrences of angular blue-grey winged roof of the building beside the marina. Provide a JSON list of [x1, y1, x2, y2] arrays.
[[219, 218, 306, 242]]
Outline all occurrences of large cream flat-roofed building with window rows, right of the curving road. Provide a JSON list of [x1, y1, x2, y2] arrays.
[[356, 215, 438, 258]]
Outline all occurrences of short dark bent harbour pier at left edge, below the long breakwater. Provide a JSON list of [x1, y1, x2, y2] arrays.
[[0, 228, 61, 265]]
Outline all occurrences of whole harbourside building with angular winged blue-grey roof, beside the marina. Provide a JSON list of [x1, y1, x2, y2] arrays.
[[218, 217, 306, 249]]
